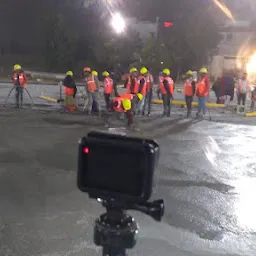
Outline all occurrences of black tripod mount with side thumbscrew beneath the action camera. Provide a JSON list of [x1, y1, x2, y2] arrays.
[[94, 200, 164, 256]]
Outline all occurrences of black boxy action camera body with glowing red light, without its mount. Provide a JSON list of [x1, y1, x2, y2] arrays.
[[77, 132, 160, 203]]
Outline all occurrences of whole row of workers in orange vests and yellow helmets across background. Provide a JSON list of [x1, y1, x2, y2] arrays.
[[12, 64, 256, 126]]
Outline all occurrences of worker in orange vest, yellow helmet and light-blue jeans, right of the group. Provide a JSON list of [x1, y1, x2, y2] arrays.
[[196, 68, 210, 117]]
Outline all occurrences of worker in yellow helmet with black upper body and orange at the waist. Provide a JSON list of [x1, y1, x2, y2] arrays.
[[63, 71, 77, 112]]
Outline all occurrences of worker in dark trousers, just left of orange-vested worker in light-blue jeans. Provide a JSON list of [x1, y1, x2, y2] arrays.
[[184, 70, 196, 117]]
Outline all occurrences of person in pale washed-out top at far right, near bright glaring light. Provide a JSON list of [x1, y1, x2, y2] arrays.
[[236, 72, 250, 113]]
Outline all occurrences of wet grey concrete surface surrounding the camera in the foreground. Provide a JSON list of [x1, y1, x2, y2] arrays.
[[0, 108, 256, 256]]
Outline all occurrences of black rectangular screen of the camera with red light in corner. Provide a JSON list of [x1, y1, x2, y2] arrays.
[[82, 143, 145, 197]]
